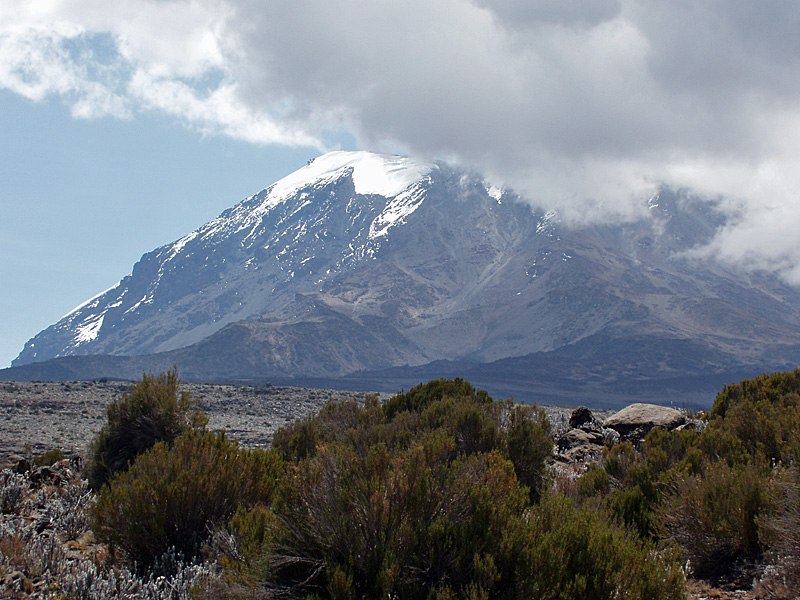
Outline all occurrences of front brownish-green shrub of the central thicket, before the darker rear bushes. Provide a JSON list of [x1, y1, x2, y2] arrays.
[[265, 435, 528, 599]]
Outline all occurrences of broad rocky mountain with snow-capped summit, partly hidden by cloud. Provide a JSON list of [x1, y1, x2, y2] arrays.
[[6, 152, 800, 400]]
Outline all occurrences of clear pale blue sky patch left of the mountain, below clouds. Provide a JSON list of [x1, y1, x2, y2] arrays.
[[0, 92, 319, 366]]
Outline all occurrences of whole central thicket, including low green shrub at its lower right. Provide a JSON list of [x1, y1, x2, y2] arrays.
[[222, 380, 683, 600]]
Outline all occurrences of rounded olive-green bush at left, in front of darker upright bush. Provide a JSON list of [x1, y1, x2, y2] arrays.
[[91, 431, 280, 570]]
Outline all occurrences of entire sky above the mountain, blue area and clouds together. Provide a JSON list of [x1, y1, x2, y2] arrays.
[[0, 0, 800, 366]]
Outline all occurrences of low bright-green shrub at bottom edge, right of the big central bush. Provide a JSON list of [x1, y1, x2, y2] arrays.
[[510, 494, 685, 600]]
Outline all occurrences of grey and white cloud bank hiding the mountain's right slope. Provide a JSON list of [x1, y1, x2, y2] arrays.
[[0, 0, 800, 283]]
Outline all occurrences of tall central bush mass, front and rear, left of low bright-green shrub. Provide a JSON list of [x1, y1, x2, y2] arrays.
[[231, 379, 553, 599]]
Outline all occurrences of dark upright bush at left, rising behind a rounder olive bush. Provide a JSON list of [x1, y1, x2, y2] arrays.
[[86, 369, 208, 490]]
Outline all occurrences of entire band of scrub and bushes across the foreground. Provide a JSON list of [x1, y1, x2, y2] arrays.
[[0, 371, 800, 600]]
